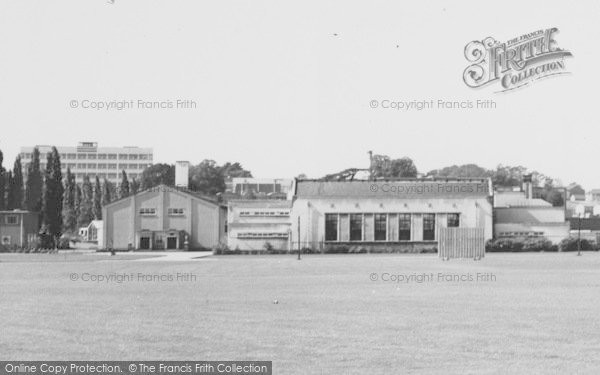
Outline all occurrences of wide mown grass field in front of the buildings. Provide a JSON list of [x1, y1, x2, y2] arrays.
[[0, 252, 600, 374]]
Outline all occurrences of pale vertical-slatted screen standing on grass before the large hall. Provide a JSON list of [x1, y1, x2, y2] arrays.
[[438, 228, 485, 260]]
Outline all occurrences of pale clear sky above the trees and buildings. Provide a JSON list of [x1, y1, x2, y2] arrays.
[[0, 0, 600, 189]]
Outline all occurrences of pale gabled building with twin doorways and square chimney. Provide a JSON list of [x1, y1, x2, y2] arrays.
[[102, 162, 227, 250]]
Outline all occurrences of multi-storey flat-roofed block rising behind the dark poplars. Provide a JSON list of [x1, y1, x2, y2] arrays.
[[21, 142, 153, 184]]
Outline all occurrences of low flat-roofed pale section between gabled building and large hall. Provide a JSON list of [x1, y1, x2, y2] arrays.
[[227, 199, 292, 251]]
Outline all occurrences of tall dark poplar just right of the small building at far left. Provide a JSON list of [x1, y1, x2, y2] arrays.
[[42, 147, 64, 248]]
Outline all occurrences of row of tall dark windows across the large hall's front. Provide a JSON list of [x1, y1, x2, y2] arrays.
[[325, 214, 460, 241]]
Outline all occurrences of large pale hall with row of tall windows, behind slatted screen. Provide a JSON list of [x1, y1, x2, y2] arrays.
[[291, 179, 493, 252]]
